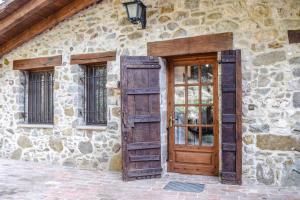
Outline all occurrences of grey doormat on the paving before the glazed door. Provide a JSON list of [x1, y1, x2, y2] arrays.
[[164, 181, 204, 193]]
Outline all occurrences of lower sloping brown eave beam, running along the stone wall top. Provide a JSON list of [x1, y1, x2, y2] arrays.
[[0, 0, 101, 57]]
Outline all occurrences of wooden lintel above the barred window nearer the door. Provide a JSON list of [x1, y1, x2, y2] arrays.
[[70, 51, 116, 65]]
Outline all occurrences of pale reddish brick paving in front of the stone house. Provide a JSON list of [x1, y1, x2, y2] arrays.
[[0, 159, 300, 200]]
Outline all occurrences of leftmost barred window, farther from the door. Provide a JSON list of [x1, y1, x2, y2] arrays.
[[28, 71, 53, 124]]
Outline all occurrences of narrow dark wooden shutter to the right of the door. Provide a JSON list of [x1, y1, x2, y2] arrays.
[[221, 50, 242, 184]]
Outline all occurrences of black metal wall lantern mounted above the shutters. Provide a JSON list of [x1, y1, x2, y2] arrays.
[[123, 0, 147, 29]]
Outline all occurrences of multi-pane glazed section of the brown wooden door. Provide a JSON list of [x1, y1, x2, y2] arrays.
[[174, 64, 214, 146]]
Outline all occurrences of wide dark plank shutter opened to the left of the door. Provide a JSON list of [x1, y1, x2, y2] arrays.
[[121, 56, 162, 181]]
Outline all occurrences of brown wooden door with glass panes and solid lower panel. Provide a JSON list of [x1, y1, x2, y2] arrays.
[[168, 54, 219, 175]]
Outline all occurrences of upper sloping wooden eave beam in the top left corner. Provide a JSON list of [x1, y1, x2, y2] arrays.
[[0, 0, 50, 35]]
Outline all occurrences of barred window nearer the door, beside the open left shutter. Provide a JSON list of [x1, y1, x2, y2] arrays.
[[85, 65, 107, 125]]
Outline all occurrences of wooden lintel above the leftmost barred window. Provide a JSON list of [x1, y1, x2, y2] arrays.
[[13, 55, 62, 70]]
